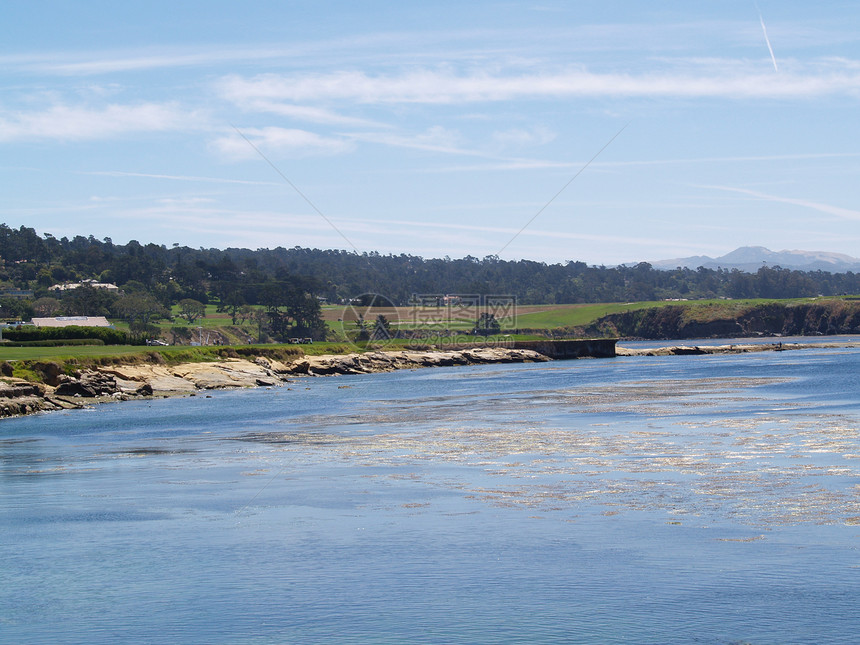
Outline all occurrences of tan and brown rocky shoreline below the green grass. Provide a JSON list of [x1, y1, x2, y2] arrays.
[[0, 347, 551, 417]]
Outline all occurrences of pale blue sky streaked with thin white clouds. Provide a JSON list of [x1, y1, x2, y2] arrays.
[[0, 0, 860, 265]]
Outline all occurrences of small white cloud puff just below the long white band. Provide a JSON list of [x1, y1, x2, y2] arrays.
[[213, 127, 355, 159]]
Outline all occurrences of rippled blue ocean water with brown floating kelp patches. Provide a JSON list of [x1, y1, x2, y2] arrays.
[[0, 349, 860, 644]]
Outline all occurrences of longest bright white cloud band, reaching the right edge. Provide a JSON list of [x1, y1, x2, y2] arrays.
[[222, 61, 860, 104]]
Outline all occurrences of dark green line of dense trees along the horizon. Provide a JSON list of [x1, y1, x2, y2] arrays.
[[0, 224, 860, 330]]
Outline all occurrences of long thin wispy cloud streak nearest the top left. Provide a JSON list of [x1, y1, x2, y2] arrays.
[[0, 27, 692, 76]]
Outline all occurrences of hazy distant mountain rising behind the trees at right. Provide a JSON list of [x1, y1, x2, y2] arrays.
[[650, 246, 860, 273]]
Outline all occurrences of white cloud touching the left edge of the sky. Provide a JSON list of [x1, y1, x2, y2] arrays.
[[0, 103, 199, 141]]
